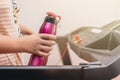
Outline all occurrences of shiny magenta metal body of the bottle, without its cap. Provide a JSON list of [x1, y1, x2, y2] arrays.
[[29, 22, 56, 66]]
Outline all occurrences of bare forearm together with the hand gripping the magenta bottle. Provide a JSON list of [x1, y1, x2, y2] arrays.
[[0, 34, 56, 56]]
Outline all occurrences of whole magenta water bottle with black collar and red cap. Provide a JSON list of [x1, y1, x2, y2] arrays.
[[28, 12, 61, 66]]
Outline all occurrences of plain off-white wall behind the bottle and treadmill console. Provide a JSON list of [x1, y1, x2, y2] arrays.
[[18, 0, 120, 65]]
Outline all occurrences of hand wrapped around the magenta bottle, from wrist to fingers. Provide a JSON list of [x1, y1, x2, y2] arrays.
[[19, 34, 56, 56]]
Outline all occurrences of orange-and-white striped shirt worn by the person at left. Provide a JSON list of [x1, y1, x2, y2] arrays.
[[0, 0, 22, 66]]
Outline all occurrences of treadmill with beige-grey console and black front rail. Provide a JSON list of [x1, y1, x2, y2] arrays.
[[0, 20, 120, 80]]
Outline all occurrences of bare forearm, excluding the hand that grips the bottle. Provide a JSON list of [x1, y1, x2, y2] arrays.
[[0, 35, 22, 53]]
